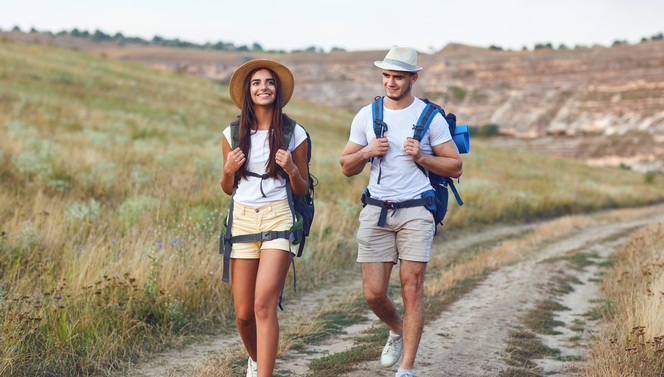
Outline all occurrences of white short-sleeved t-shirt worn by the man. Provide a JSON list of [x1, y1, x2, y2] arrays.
[[349, 98, 452, 202]]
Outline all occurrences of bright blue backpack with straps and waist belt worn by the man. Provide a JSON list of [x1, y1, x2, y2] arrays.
[[362, 97, 470, 231]]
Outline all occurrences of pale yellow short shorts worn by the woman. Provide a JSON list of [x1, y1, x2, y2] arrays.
[[231, 199, 297, 259]]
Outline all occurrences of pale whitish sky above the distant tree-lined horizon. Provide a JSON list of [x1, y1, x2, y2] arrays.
[[0, 0, 664, 52]]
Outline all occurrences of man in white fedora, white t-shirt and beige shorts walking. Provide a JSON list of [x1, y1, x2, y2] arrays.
[[339, 47, 462, 377]]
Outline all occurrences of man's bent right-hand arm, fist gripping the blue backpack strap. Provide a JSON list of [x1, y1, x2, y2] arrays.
[[404, 137, 463, 178]]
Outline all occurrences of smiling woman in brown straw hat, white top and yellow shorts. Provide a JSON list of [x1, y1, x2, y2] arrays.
[[221, 60, 308, 377]]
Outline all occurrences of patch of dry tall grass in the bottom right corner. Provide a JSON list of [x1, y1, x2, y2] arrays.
[[585, 222, 664, 376]]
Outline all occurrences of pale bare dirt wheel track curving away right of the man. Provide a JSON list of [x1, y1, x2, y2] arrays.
[[344, 209, 664, 377]]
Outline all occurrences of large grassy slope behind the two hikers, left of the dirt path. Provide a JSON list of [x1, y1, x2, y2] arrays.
[[0, 41, 664, 376]]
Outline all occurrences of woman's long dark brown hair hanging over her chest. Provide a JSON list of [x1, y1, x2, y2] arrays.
[[238, 67, 289, 179]]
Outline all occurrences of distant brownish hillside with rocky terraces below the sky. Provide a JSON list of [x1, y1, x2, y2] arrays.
[[1, 32, 664, 172]]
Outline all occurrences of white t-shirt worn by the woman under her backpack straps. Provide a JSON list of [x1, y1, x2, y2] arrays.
[[224, 124, 307, 207]]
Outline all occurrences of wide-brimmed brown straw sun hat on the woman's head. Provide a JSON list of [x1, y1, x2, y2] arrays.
[[228, 59, 295, 109]]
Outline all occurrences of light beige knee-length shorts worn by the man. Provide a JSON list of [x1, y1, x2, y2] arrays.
[[357, 205, 435, 263]]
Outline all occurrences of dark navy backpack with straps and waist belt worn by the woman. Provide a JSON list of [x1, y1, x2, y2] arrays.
[[219, 118, 318, 308]]
